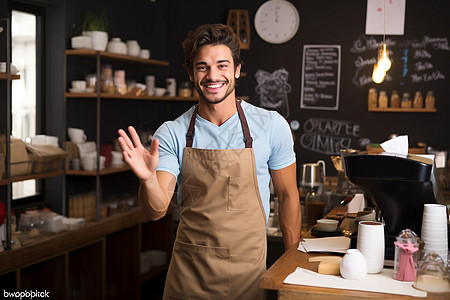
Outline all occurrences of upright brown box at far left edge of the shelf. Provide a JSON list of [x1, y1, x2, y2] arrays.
[[0, 138, 32, 177]]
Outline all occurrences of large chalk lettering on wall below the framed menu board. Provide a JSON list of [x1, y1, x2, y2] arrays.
[[300, 118, 370, 155]]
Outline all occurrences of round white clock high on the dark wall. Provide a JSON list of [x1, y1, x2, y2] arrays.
[[255, 0, 300, 44]]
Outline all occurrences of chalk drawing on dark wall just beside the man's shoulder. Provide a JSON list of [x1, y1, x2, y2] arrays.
[[254, 69, 292, 118]]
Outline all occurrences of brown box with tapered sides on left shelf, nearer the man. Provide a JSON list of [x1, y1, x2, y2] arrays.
[[27, 145, 67, 174]]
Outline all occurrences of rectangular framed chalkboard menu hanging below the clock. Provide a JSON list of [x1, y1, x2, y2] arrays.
[[300, 45, 341, 110]]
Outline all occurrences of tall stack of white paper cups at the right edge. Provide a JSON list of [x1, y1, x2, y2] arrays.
[[421, 204, 448, 263]]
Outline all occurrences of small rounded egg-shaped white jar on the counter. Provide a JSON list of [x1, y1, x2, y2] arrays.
[[340, 249, 367, 280]]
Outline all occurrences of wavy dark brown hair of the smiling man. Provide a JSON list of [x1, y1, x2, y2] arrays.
[[182, 24, 242, 74]]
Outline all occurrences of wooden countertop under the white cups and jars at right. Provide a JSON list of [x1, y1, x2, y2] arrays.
[[260, 209, 450, 300]]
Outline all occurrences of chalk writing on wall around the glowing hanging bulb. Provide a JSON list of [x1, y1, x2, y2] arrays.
[[350, 35, 450, 87]]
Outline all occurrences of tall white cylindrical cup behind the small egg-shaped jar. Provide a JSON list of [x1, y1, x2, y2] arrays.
[[356, 221, 384, 274]]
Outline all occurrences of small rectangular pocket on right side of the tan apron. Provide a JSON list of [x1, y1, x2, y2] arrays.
[[227, 176, 249, 211]]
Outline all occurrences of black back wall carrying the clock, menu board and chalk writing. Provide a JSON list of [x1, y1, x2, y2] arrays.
[[167, 0, 450, 174]]
